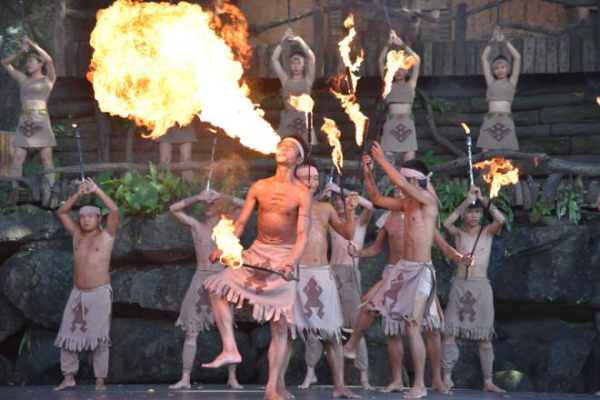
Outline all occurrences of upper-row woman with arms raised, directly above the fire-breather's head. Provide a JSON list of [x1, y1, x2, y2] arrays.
[[271, 29, 318, 145]]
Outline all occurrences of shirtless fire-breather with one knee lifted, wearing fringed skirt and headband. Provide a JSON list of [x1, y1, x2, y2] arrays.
[[203, 136, 312, 400]]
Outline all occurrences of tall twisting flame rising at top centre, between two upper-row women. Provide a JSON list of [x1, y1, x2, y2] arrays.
[[332, 14, 368, 146]]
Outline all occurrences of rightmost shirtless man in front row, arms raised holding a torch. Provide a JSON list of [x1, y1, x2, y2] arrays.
[[442, 186, 504, 393]]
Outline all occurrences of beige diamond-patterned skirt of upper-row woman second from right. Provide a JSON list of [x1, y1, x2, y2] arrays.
[[381, 114, 418, 153]]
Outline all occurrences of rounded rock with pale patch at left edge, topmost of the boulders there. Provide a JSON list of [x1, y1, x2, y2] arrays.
[[0, 204, 68, 259]]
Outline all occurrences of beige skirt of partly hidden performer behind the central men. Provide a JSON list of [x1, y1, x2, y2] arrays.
[[331, 265, 362, 328]]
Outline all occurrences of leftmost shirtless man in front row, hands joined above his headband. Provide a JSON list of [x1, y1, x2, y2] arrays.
[[54, 179, 119, 390]]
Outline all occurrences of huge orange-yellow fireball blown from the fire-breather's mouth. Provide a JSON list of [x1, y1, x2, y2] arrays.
[[88, 0, 280, 153]]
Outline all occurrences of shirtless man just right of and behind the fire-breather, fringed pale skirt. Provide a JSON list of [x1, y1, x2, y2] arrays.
[[292, 163, 360, 399]]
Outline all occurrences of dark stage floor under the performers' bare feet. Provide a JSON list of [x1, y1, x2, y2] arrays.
[[0, 385, 599, 400]]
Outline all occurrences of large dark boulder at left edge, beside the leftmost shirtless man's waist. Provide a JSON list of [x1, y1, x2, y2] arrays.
[[0, 247, 73, 329]]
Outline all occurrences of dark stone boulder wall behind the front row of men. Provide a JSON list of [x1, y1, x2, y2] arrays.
[[0, 206, 600, 392]]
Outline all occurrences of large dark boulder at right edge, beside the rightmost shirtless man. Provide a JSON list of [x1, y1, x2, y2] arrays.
[[490, 225, 600, 305]]
